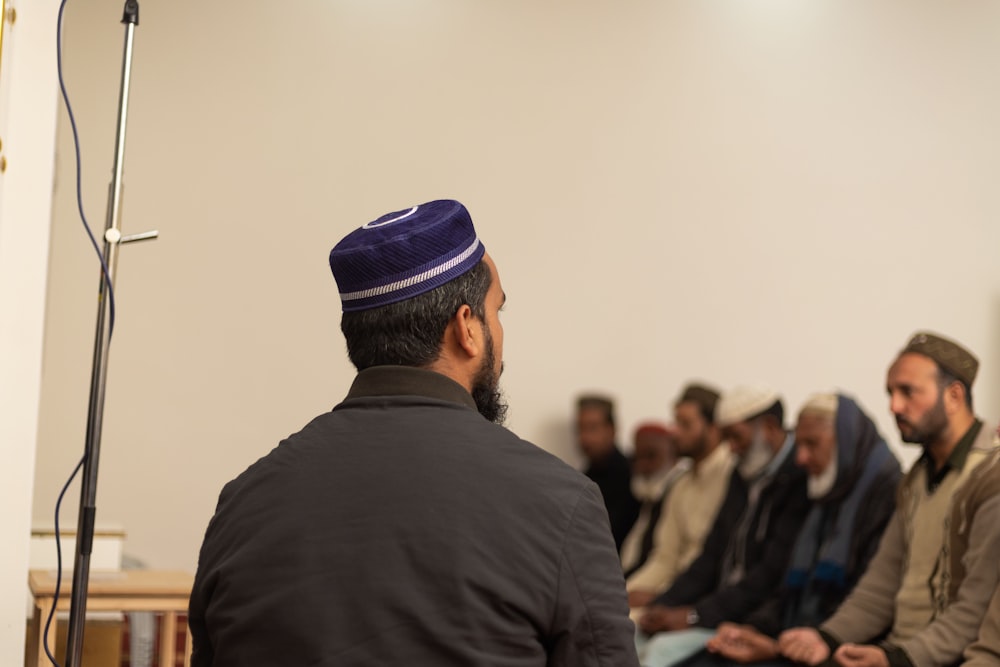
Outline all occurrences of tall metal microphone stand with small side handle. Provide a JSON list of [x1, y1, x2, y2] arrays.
[[63, 0, 158, 667]]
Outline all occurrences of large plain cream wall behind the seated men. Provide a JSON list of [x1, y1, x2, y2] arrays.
[[34, 0, 1000, 569]]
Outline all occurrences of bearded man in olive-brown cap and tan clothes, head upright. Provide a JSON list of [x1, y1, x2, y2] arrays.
[[778, 332, 1000, 667]]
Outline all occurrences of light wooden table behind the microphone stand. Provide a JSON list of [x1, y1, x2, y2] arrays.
[[28, 570, 194, 667]]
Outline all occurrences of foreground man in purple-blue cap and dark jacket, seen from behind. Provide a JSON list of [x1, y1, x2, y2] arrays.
[[190, 200, 637, 667]]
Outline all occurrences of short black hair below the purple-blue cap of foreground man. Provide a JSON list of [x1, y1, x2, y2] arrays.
[[340, 260, 493, 371]]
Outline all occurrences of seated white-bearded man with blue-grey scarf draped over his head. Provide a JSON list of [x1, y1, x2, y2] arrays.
[[684, 394, 902, 667]]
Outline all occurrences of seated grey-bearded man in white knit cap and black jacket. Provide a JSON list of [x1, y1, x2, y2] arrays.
[[636, 387, 810, 667]]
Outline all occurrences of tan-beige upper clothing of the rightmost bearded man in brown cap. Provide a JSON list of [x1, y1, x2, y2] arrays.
[[820, 421, 1000, 667]]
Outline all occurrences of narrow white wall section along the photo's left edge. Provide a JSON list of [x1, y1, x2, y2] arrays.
[[0, 0, 59, 665]]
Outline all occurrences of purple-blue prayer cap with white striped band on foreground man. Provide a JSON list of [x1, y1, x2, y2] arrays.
[[330, 199, 486, 313]]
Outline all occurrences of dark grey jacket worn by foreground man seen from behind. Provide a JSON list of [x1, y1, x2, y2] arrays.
[[190, 367, 637, 667]]
